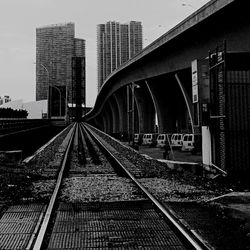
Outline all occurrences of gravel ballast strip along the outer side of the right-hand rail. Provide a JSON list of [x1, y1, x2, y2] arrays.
[[85, 124, 227, 202]]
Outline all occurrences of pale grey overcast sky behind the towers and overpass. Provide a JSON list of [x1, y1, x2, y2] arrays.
[[0, 0, 209, 106]]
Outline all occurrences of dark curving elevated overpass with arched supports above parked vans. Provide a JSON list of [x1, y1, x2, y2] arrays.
[[84, 0, 250, 180]]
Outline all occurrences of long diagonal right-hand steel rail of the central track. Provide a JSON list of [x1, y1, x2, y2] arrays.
[[82, 124, 211, 250]]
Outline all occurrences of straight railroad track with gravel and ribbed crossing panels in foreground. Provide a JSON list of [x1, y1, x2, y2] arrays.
[[0, 123, 208, 250]]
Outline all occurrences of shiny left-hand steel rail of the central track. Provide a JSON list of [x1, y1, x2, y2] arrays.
[[33, 124, 77, 250]]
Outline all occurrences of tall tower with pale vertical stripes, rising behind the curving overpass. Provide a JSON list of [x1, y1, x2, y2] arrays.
[[97, 21, 142, 91]]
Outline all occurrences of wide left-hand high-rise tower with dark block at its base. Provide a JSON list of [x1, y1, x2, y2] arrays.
[[36, 23, 85, 117]]
